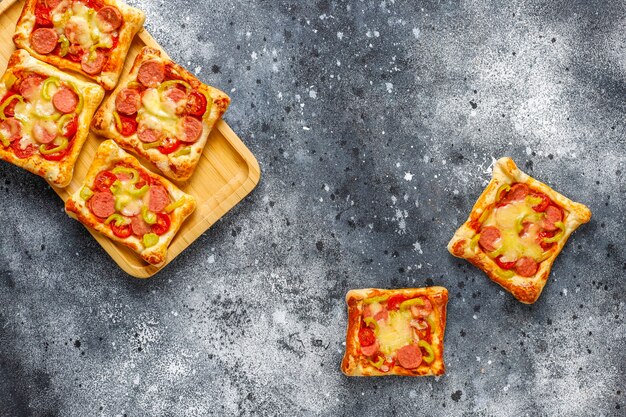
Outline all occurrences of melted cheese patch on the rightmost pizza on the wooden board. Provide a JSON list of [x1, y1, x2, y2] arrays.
[[137, 88, 178, 137]]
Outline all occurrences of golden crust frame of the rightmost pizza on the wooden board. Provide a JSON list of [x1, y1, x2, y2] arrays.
[[91, 47, 230, 181]]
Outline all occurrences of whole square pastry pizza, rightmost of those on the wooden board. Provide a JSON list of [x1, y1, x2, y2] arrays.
[[92, 47, 230, 181]]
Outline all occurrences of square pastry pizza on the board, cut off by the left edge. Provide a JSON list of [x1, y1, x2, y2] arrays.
[[0, 50, 104, 187]]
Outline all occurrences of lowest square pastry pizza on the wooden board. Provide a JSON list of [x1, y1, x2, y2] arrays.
[[65, 140, 196, 266]]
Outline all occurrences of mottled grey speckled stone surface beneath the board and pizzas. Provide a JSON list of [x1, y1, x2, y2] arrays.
[[0, 0, 626, 416]]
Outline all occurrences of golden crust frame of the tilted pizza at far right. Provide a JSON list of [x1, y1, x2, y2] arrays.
[[448, 158, 591, 304]]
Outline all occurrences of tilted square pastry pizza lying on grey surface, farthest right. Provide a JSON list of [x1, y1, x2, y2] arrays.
[[448, 158, 591, 304]]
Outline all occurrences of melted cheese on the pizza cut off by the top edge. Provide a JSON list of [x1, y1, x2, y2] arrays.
[[51, 0, 115, 51]]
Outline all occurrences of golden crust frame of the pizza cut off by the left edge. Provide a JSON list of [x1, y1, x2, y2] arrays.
[[0, 49, 104, 188]]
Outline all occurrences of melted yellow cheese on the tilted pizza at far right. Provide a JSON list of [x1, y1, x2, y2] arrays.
[[483, 199, 543, 262]]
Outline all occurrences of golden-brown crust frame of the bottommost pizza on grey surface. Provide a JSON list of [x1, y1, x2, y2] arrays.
[[341, 287, 448, 376]]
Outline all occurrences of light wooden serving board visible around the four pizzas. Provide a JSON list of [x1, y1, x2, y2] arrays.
[[0, 0, 261, 278]]
